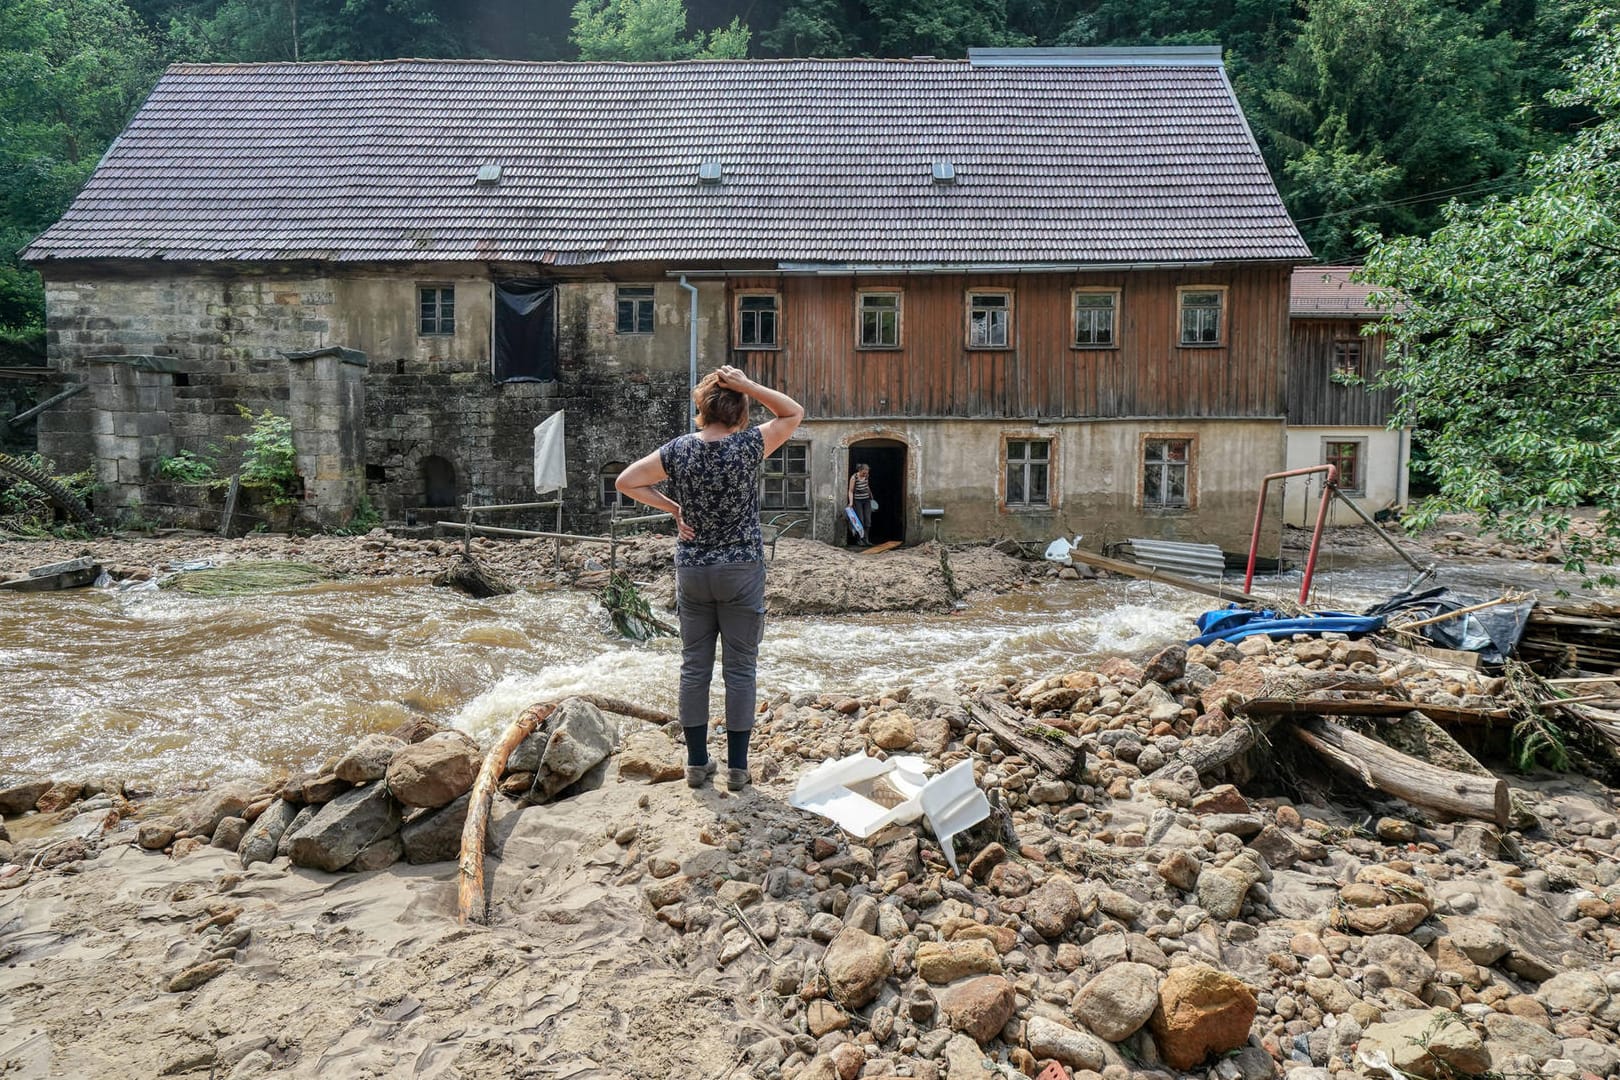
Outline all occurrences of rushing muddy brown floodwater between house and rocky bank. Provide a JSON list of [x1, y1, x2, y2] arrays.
[[0, 553, 1607, 789]]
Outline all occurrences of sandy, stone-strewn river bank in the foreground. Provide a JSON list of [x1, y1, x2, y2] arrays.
[[0, 615, 1620, 1080]]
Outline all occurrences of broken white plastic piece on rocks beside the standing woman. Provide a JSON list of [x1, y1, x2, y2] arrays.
[[787, 753, 990, 870]]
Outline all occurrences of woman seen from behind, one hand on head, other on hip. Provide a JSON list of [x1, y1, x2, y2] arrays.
[[614, 366, 805, 792]]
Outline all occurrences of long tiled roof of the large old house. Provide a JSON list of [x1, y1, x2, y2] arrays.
[[24, 50, 1309, 266]]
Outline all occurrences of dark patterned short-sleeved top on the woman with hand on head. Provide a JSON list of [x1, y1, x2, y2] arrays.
[[658, 427, 765, 567]]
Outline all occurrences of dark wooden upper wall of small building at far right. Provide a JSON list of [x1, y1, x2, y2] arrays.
[[1288, 316, 1396, 427]]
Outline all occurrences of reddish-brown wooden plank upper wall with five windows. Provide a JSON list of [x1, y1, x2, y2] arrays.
[[727, 264, 1290, 419]]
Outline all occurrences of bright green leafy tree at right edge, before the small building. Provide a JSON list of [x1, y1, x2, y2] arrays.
[[1366, 10, 1620, 581]]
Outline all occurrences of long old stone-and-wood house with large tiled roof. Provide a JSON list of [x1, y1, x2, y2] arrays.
[[26, 47, 1309, 544]]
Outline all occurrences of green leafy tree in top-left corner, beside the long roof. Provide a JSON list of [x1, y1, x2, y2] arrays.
[[0, 0, 159, 327]]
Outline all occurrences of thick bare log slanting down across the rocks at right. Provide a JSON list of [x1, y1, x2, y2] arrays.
[[1294, 717, 1511, 829]]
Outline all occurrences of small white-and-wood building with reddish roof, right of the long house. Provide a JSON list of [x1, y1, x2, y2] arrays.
[[1285, 266, 1411, 526]]
